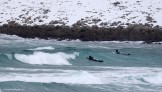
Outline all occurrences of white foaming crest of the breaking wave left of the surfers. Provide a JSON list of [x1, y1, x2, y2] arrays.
[[14, 52, 79, 65]]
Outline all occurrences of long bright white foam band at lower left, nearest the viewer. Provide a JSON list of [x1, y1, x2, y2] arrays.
[[0, 71, 102, 84]]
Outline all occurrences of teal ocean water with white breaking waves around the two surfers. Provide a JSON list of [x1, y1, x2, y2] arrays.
[[0, 34, 162, 92]]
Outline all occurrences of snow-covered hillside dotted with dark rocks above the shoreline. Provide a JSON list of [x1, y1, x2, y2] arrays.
[[0, 0, 162, 26]]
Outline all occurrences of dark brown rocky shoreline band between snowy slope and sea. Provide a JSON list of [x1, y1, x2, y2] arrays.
[[0, 22, 162, 43]]
